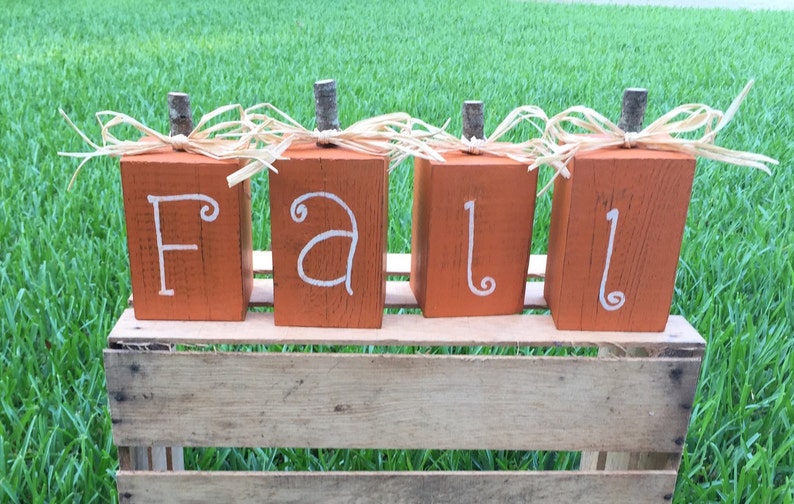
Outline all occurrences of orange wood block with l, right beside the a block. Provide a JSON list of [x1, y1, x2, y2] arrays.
[[410, 152, 538, 317]]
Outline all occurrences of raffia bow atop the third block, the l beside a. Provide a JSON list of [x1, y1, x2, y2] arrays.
[[420, 105, 570, 177]]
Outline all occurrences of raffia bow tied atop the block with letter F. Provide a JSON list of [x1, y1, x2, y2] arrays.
[[58, 104, 291, 188]]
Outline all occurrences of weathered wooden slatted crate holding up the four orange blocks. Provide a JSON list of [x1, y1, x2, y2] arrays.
[[105, 252, 705, 504]]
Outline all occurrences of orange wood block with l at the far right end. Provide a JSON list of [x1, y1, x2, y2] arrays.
[[544, 149, 695, 331]]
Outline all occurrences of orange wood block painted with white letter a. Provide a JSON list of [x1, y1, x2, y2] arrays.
[[270, 145, 389, 328]]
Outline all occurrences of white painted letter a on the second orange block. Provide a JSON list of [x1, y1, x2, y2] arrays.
[[289, 192, 358, 296]]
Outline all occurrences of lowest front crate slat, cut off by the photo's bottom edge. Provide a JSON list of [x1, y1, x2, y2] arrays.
[[118, 471, 676, 504]]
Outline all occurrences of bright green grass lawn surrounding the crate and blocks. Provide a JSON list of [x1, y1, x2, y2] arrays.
[[0, 0, 794, 503]]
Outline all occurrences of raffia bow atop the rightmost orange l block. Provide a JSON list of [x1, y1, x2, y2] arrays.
[[534, 80, 778, 187]]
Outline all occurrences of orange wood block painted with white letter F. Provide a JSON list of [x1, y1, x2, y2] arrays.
[[121, 148, 253, 320]]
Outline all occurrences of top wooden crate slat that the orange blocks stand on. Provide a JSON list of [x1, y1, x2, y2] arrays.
[[108, 309, 705, 352]]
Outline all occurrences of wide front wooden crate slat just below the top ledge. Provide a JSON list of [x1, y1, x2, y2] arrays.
[[105, 350, 700, 452]]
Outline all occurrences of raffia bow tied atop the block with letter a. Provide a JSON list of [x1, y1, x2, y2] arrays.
[[226, 103, 444, 187]]
